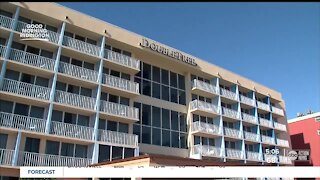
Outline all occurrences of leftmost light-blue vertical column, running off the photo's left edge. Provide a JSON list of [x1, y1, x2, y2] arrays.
[[0, 7, 20, 89]]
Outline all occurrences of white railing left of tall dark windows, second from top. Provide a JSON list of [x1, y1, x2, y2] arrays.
[[102, 74, 139, 94]]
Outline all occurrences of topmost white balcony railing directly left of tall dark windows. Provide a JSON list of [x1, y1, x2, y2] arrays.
[[104, 49, 140, 70]]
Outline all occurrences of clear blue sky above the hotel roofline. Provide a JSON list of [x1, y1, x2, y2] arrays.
[[60, 2, 320, 119]]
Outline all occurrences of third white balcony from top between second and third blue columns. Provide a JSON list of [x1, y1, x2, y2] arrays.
[[54, 90, 96, 110]]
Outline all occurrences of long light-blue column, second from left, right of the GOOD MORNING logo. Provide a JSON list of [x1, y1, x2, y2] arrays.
[[45, 22, 66, 134]]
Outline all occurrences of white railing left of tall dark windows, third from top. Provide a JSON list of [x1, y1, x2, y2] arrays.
[[100, 101, 139, 120]]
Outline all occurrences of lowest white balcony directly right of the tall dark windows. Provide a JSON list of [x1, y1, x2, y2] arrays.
[[193, 144, 223, 158]]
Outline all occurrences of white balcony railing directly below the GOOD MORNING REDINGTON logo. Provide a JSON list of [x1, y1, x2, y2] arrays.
[[9, 46, 55, 71]]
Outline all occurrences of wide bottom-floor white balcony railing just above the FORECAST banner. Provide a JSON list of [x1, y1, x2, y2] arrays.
[[18, 152, 91, 167]]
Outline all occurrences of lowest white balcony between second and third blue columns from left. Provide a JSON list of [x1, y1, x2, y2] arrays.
[[50, 121, 93, 140]]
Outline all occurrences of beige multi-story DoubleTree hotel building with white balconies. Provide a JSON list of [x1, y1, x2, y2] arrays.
[[0, 2, 291, 179]]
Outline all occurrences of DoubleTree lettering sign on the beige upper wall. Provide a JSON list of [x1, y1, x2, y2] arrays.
[[140, 38, 197, 66]]
